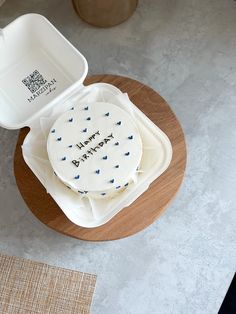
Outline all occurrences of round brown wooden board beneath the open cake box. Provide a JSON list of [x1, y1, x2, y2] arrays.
[[14, 75, 186, 241]]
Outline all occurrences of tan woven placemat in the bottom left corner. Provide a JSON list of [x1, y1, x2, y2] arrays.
[[0, 254, 96, 314]]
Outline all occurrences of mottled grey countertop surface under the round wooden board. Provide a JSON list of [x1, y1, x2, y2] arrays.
[[0, 0, 236, 314]]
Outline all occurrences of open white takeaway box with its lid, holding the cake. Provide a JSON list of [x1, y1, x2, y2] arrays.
[[0, 14, 172, 228]]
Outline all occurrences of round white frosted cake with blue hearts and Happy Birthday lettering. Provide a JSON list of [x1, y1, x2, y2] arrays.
[[47, 102, 142, 197]]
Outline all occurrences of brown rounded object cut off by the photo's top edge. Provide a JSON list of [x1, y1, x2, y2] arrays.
[[72, 0, 138, 27]]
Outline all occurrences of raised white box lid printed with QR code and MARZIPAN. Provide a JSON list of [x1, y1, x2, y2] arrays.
[[0, 14, 88, 129]]
